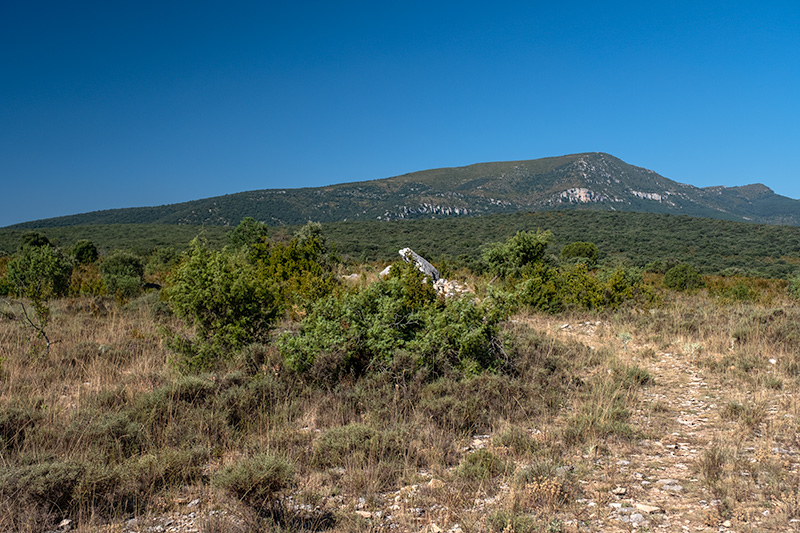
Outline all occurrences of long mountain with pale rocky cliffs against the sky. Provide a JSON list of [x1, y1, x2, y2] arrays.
[[10, 152, 800, 227]]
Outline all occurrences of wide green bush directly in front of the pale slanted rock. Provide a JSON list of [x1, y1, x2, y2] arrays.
[[279, 263, 502, 379]]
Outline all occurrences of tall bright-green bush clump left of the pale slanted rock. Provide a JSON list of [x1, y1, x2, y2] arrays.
[[165, 219, 337, 369]]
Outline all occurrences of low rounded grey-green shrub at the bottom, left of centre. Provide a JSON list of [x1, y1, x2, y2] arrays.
[[213, 453, 294, 507]]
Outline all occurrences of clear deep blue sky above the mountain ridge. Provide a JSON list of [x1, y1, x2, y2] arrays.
[[0, 0, 800, 226]]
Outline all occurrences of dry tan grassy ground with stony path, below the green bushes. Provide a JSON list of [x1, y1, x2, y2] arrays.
[[0, 280, 800, 532]]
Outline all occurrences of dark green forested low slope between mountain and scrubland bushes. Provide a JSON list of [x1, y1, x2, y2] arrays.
[[0, 211, 800, 277]]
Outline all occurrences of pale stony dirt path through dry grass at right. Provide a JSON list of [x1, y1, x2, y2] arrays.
[[550, 323, 800, 532]]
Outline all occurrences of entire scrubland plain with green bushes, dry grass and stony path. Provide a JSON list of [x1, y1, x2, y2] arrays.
[[0, 219, 800, 532]]
